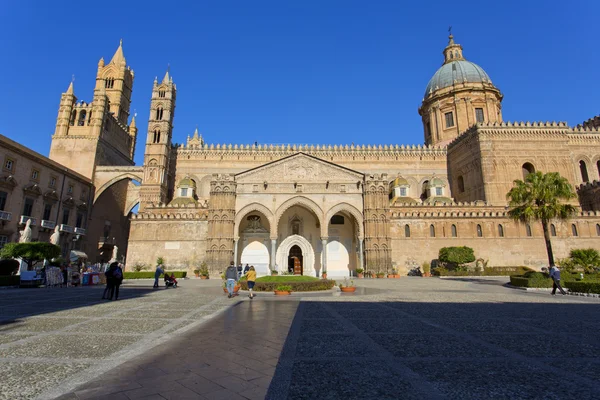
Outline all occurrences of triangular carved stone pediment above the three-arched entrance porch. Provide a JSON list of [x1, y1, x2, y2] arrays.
[[235, 153, 364, 183]]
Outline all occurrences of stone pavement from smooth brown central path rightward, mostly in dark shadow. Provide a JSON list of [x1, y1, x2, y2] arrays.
[[45, 278, 600, 400]]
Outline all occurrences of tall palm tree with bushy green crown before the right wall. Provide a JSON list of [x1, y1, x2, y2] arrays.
[[506, 172, 577, 266]]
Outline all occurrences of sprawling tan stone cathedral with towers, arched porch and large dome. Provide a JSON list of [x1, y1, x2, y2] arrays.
[[43, 35, 600, 277]]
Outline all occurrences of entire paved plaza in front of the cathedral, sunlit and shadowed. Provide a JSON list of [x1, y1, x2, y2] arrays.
[[0, 277, 600, 400]]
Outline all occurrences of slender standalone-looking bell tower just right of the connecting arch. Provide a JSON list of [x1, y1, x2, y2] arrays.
[[140, 69, 177, 210]]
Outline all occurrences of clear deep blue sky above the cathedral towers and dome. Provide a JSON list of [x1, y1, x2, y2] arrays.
[[0, 0, 600, 163]]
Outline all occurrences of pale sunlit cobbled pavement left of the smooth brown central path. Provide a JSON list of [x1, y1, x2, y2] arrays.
[[0, 280, 231, 400]]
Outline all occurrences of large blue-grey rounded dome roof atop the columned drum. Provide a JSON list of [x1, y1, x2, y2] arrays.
[[425, 60, 492, 97]]
